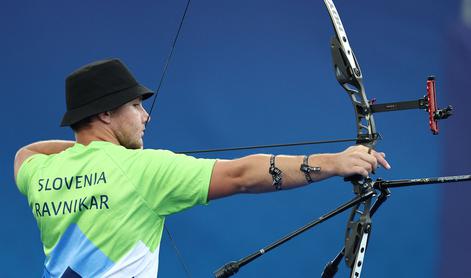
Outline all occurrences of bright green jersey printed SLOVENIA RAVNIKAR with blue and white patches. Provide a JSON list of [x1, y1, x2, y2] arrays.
[[17, 141, 215, 277]]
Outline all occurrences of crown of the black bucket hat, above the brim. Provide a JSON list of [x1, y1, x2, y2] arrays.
[[66, 59, 138, 110]]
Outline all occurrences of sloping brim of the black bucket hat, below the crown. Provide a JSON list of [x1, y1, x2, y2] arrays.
[[61, 84, 154, 126]]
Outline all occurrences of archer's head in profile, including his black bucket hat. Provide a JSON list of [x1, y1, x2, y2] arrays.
[[61, 59, 153, 149]]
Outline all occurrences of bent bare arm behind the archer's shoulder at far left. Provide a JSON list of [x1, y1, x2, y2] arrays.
[[14, 140, 75, 180]]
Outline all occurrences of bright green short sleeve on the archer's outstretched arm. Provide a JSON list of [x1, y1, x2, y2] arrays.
[[121, 150, 216, 216]]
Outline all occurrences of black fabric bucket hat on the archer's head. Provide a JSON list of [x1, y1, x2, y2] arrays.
[[61, 59, 154, 126]]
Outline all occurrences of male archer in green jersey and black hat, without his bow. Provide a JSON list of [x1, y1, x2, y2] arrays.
[[14, 59, 390, 277]]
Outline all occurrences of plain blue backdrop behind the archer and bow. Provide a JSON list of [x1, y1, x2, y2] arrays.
[[0, 0, 471, 277]]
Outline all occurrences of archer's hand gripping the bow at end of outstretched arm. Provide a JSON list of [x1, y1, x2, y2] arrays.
[[333, 145, 391, 177]]
